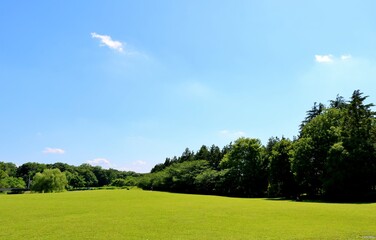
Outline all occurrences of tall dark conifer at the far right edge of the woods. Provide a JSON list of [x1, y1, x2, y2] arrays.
[[328, 90, 376, 198]]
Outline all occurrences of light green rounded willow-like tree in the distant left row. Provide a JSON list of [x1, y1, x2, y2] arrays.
[[31, 168, 68, 193]]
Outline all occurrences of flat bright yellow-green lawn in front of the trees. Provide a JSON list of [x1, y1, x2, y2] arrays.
[[0, 190, 376, 240]]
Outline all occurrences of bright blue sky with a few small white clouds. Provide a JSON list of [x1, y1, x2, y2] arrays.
[[0, 0, 376, 172]]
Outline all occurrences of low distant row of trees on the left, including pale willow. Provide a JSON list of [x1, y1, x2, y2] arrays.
[[0, 162, 140, 192]]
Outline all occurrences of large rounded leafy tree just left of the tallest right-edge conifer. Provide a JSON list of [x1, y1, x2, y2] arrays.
[[293, 108, 344, 197]]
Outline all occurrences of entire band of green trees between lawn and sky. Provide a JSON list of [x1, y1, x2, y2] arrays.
[[0, 90, 376, 201]]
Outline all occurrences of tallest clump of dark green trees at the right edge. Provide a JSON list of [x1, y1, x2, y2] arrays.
[[293, 90, 376, 200]]
